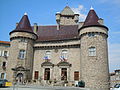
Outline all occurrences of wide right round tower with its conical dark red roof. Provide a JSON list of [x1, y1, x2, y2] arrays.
[[79, 8, 109, 90]]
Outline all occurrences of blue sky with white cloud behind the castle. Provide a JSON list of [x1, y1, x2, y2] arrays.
[[0, 0, 120, 72]]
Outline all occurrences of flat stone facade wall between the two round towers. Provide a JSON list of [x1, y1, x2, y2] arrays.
[[33, 41, 80, 84]]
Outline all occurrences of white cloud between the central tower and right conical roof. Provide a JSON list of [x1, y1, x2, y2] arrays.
[[72, 5, 86, 21]]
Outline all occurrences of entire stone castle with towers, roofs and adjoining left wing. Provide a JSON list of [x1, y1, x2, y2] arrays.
[[0, 6, 109, 90]]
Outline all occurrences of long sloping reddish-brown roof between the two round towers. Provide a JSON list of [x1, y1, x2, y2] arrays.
[[37, 25, 78, 41]]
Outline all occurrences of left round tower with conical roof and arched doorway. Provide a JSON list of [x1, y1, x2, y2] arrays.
[[8, 13, 37, 82]]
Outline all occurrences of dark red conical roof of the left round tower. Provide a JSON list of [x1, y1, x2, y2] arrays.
[[10, 13, 34, 34]]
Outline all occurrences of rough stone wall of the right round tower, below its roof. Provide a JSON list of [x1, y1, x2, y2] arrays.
[[80, 27, 109, 90]]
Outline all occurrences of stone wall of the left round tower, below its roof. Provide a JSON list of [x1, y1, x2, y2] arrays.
[[7, 32, 36, 81]]
